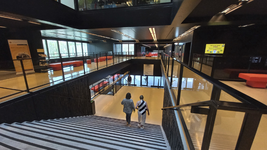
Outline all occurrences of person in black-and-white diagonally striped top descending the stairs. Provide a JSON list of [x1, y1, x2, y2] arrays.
[[135, 95, 149, 129]]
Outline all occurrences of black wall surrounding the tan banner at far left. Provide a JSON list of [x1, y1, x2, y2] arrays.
[[0, 29, 43, 69]]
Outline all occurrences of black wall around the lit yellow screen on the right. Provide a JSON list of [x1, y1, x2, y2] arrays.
[[192, 26, 267, 57]]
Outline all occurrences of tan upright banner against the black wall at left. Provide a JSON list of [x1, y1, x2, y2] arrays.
[[8, 40, 34, 75]]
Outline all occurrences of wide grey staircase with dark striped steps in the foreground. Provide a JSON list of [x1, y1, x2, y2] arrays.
[[0, 116, 169, 150]]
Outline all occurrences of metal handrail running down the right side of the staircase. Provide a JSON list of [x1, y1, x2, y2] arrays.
[[160, 59, 195, 150]]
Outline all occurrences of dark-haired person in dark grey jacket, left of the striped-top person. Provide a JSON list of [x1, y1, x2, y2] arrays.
[[121, 93, 135, 127]]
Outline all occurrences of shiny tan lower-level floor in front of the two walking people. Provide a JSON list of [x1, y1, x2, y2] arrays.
[[95, 86, 164, 125]]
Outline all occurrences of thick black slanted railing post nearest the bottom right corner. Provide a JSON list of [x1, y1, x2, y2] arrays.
[[235, 112, 262, 150]]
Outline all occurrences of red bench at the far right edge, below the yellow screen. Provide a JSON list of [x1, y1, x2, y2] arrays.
[[238, 73, 267, 88]]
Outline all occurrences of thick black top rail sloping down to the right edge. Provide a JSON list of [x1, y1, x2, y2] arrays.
[[171, 55, 267, 109]]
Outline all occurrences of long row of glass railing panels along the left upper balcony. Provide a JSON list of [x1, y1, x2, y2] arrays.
[[0, 57, 158, 103]]
